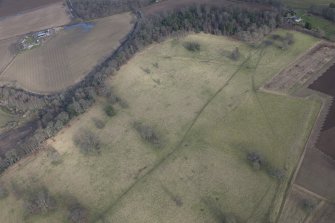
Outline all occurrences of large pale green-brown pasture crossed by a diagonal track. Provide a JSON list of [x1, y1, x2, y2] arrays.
[[0, 31, 320, 223]]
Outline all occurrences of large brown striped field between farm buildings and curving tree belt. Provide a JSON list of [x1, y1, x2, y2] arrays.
[[0, 13, 133, 94]]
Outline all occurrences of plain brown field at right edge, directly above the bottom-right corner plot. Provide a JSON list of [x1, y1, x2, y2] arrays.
[[295, 148, 335, 201]]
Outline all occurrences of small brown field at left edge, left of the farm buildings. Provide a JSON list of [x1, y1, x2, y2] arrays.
[[0, 38, 17, 74]]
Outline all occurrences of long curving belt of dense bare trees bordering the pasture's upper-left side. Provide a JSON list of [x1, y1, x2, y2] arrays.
[[0, 5, 282, 172]]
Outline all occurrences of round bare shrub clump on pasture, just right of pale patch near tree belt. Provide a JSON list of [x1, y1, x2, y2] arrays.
[[73, 129, 101, 154]]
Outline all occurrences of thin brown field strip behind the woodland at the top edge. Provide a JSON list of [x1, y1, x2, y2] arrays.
[[143, 0, 271, 15]]
